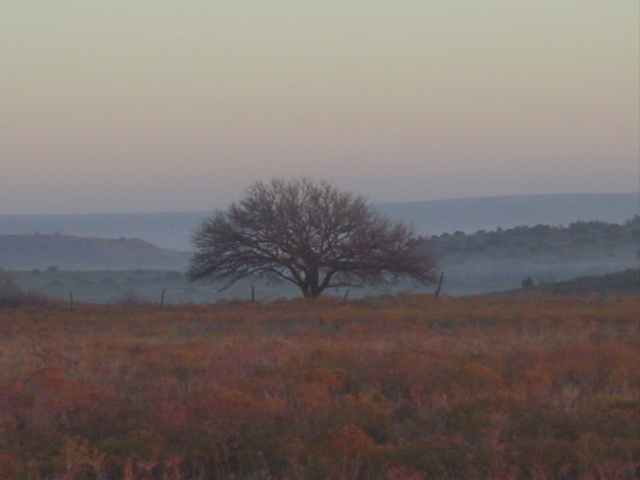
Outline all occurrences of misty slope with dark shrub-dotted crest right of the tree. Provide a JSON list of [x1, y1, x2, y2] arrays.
[[427, 216, 640, 295]]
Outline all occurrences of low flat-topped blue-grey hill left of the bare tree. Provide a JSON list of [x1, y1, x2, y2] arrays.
[[0, 234, 188, 270]]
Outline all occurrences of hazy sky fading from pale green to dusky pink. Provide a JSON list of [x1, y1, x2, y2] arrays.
[[0, 0, 640, 214]]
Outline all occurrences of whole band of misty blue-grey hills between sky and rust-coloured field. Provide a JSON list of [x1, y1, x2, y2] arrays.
[[0, 193, 640, 303]]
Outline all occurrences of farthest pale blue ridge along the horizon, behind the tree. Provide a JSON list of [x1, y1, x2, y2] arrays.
[[0, 192, 640, 251]]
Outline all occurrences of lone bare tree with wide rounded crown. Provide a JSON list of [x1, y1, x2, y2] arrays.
[[187, 178, 437, 297]]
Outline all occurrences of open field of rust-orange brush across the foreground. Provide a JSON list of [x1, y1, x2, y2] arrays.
[[0, 294, 640, 480]]
